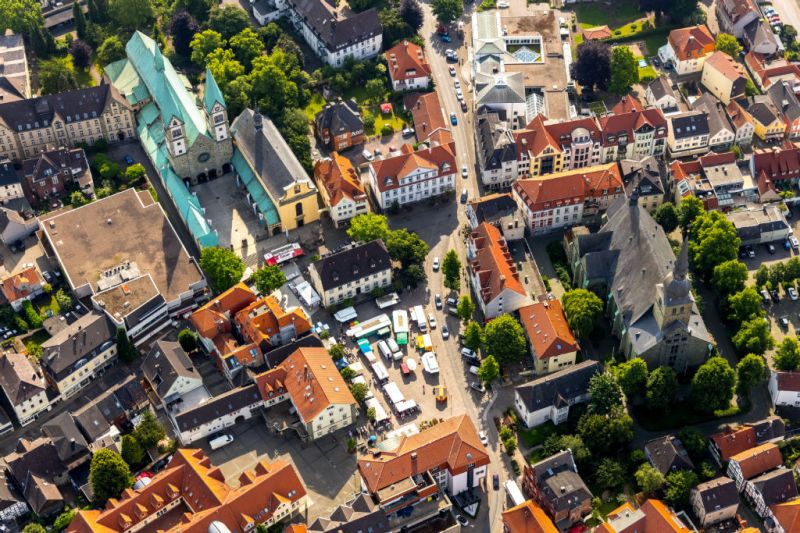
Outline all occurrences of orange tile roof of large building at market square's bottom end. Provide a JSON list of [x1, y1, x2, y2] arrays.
[[358, 415, 490, 493]]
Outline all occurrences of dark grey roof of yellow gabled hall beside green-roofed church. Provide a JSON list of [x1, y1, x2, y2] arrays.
[[231, 109, 310, 202]]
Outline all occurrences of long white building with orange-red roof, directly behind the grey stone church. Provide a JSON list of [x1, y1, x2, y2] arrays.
[[512, 162, 625, 234]]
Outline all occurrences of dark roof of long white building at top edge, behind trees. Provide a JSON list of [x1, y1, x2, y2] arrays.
[[289, 0, 383, 51]]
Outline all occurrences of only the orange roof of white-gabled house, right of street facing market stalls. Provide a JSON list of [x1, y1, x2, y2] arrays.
[[470, 222, 527, 303]]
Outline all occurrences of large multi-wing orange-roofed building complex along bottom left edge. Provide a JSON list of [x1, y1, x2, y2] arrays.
[[66, 448, 308, 533]]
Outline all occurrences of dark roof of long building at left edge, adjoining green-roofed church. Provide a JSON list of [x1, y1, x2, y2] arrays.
[[0, 84, 127, 132]]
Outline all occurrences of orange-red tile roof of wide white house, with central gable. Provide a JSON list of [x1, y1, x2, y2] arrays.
[[370, 143, 456, 192]]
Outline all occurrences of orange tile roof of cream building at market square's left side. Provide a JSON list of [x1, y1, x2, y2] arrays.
[[255, 347, 356, 423]]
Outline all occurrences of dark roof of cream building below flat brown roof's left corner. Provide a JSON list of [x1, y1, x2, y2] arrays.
[[40, 312, 117, 380]]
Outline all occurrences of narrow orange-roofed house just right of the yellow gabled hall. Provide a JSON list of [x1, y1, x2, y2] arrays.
[[314, 151, 370, 228]]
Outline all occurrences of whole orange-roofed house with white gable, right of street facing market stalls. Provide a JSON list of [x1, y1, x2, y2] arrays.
[[467, 222, 533, 320]]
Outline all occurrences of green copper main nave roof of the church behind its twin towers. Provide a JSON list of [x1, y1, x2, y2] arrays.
[[125, 31, 207, 146]]
